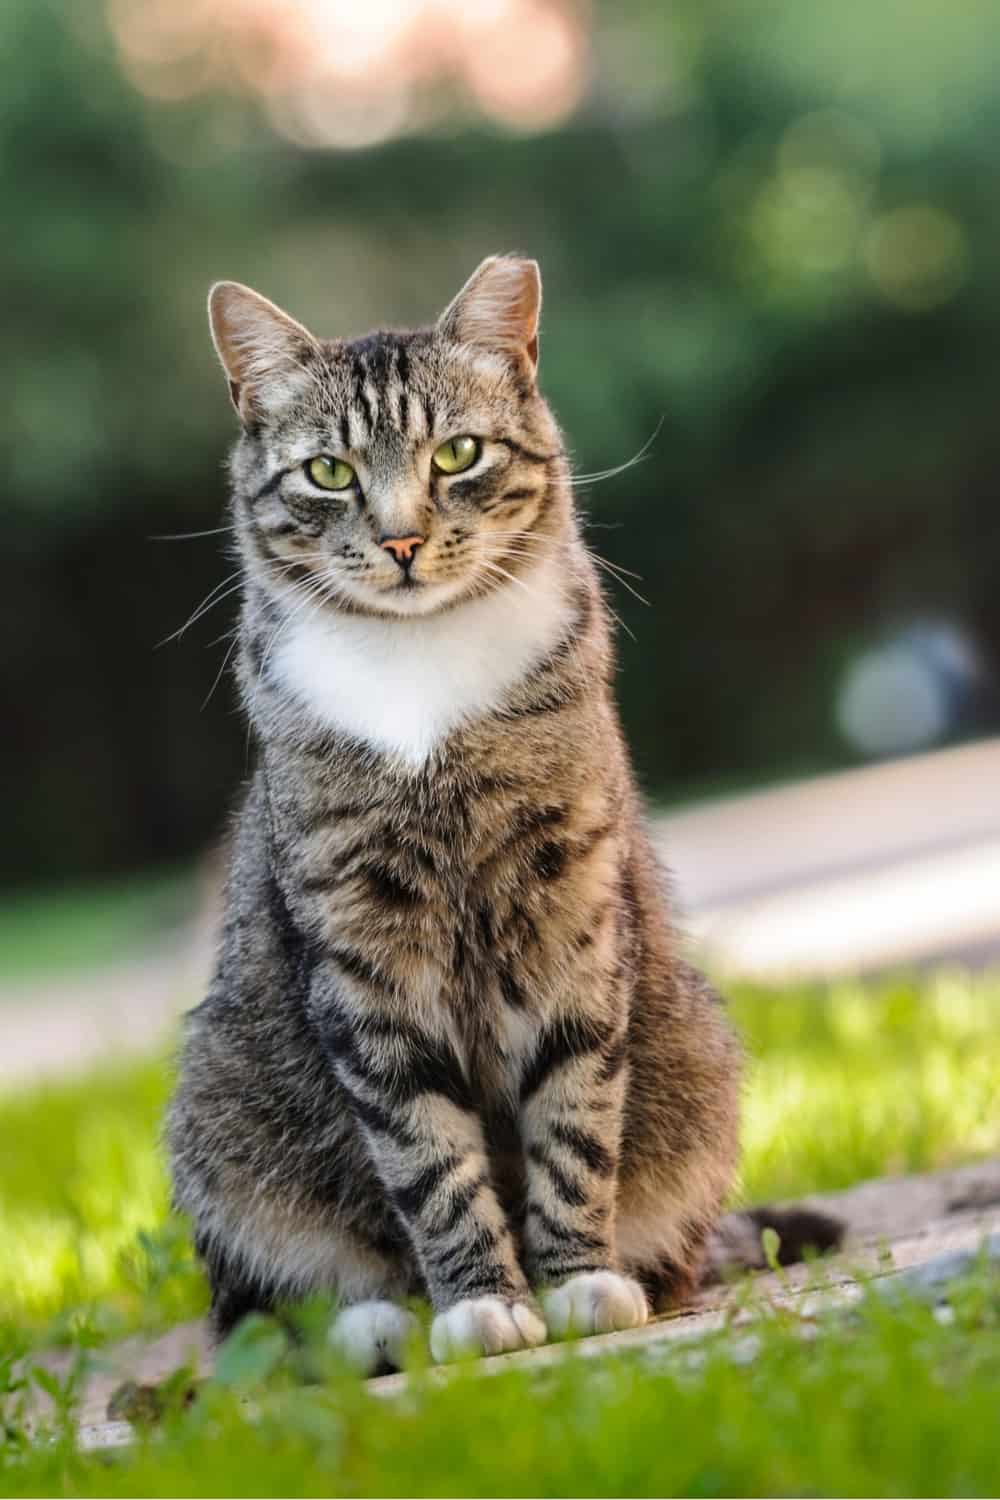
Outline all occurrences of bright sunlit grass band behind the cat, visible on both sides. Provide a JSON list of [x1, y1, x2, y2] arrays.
[[0, 974, 1000, 1337]]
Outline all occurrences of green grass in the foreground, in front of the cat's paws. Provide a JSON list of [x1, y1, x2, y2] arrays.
[[0, 1271, 1000, 1497]]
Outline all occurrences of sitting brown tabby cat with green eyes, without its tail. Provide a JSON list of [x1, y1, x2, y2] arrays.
[[168, 257, 741, 1370]]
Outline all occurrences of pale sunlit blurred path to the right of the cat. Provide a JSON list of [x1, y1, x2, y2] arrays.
[[655, 738, 1000, 981]]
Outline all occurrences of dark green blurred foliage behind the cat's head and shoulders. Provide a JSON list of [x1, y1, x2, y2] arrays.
[[0, 0, 1000, 878]]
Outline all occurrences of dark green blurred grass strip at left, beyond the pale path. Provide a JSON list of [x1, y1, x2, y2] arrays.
[[0, 867, 195, 980]]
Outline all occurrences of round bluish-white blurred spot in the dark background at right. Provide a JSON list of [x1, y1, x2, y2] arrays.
[[837, 621, 984, 756]]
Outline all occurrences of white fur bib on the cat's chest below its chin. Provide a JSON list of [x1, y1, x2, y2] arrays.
[[274, 558, 570, 767]]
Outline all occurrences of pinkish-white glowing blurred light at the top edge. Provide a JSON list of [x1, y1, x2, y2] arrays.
[[108, 0, 589, 147]]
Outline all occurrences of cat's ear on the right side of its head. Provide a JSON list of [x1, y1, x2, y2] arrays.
[[438, 255, 541, 371]]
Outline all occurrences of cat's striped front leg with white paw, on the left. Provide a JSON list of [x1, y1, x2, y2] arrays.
[[310, 956, 546, 1361]]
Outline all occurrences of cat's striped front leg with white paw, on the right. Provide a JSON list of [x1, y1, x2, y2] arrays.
[[520, 1008, 649, 1335]]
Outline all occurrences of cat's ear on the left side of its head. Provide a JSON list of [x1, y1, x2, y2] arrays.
[[208, 282, 319, 423]]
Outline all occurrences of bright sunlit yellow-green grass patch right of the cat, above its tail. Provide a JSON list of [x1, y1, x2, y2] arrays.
[[732, 972, 1000, 1202]]
